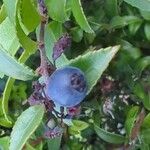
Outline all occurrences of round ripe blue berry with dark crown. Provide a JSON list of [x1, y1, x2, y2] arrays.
[[46, 66, 87, 107]]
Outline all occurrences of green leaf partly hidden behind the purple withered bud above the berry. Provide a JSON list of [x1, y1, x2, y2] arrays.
[[43, 21, 68, 68]]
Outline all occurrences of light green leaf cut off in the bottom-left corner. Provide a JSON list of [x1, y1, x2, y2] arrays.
[[0, 136, 10, 150]]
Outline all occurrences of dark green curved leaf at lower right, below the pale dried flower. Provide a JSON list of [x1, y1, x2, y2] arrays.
[[94, 125, 125, 144]]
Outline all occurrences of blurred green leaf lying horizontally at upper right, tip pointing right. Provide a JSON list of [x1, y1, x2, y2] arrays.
[[110, 16, 142, 29]]
